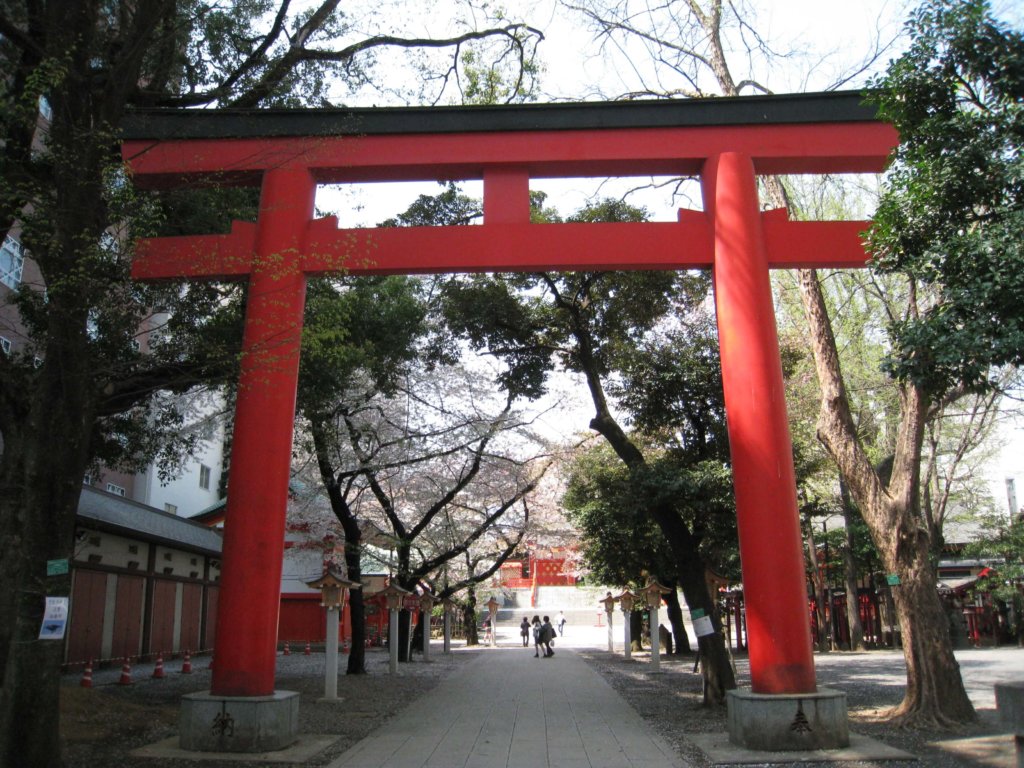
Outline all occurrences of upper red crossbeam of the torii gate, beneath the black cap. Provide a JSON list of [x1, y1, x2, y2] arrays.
[[122, 123, 896, 186]]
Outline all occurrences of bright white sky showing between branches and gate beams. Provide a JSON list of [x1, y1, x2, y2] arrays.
[[317, 0, 1024, 512]]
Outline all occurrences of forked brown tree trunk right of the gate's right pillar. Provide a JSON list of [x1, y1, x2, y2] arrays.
[[800, 270, 976, 727]]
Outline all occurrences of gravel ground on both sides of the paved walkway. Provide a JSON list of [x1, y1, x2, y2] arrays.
[[61, 643, 1024, 768]]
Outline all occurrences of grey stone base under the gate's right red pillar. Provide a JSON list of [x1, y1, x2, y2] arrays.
[[727, 688, 850, 752]]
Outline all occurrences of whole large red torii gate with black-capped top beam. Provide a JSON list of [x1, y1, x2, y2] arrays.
[[123, 92, 897, 753]]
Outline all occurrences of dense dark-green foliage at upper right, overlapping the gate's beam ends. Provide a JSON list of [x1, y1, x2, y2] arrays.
[[869, 0, 1024, 395]]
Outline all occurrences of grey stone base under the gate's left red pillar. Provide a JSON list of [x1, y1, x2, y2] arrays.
[[178, 690, 299, 752]]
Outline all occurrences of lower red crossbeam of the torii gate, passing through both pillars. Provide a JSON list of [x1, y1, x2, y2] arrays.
[[132, 211, 867, 281]]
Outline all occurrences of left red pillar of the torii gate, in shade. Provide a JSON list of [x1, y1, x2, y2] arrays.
[[211, 168, 315, 696]]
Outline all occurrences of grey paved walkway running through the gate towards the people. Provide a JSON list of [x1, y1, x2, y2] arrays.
[[330, 647, 682, 768]]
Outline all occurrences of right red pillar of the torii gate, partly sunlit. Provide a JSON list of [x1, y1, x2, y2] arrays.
[[701, 153, 816, 693]]
